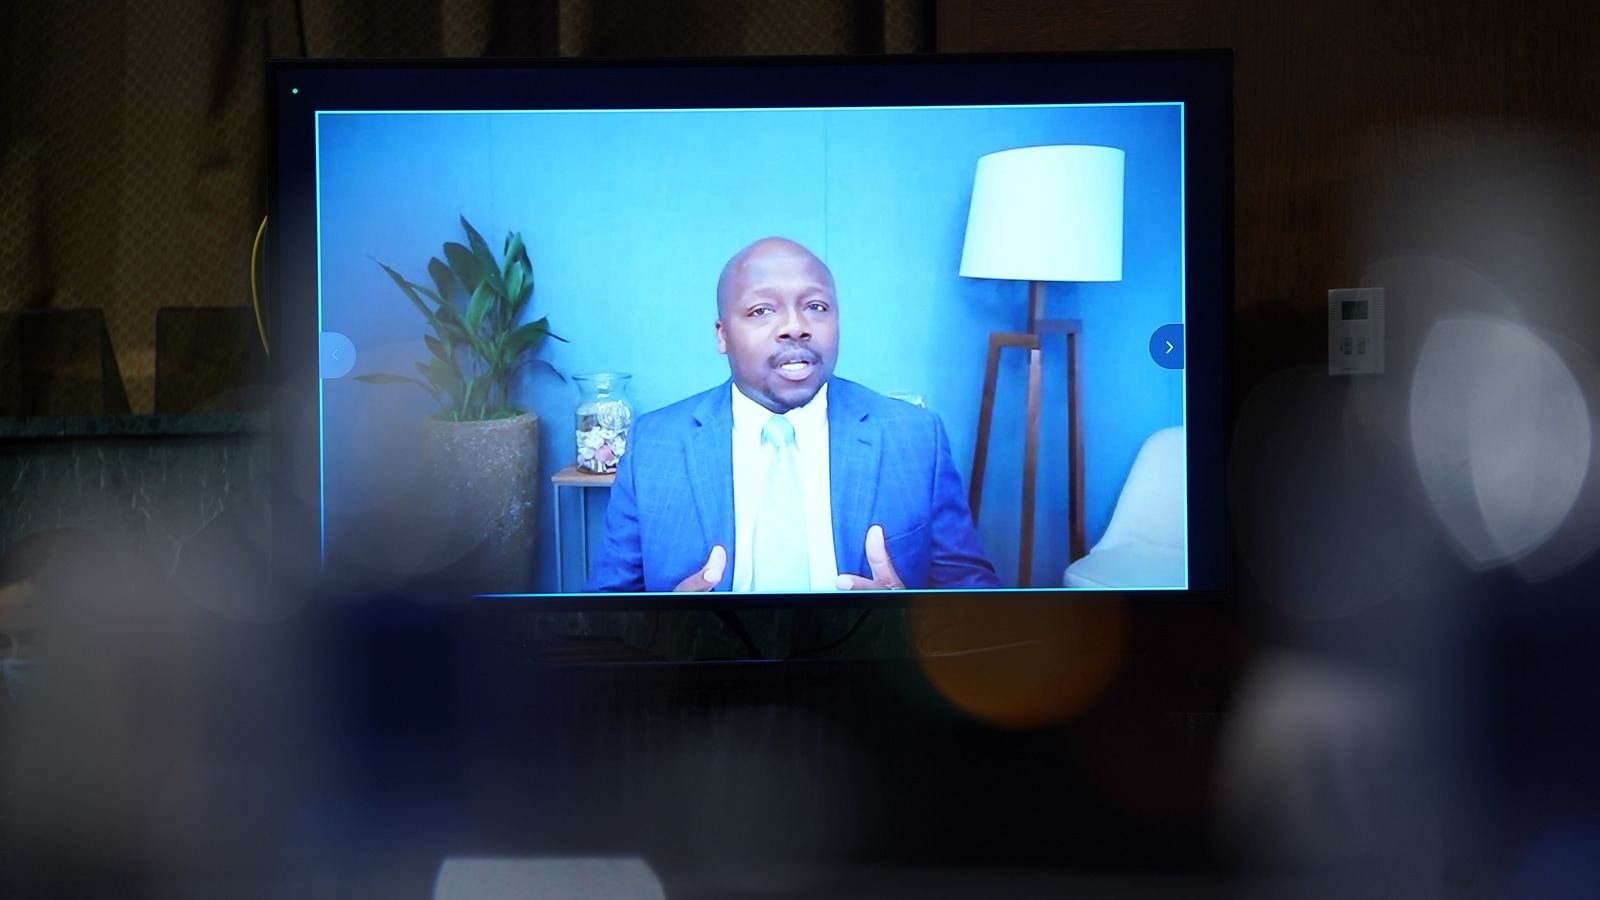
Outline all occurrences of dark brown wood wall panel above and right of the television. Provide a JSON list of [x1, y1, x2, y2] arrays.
[[938, 0, 1600, 384]]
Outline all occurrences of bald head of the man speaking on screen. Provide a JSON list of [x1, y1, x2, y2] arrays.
[[717, 237, 838, 413]]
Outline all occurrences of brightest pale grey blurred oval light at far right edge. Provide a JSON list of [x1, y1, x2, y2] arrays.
[[1411, 317, 1594, 569]]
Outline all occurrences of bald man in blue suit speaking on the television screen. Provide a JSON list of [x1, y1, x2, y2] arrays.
[[586, 239, 1000, 593]]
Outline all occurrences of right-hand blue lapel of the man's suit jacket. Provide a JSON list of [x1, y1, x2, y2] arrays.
[[827, 378, 883, 577]]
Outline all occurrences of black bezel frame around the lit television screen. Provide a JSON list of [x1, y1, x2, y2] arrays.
[[262, 50, 1234, 612]]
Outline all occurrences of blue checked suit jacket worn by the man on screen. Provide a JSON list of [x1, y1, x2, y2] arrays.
[[586, 378, 1000, 591]]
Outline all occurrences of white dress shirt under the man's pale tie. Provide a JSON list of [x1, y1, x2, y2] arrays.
[[731, 383, 838, 591]]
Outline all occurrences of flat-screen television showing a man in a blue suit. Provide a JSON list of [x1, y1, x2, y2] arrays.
[[262, 51, 1234, 609]]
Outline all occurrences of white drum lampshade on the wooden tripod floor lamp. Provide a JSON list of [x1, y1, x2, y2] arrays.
[[962, 146, 1126, 282]]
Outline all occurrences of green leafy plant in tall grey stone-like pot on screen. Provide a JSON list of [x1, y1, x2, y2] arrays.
[[357, 216, 562, 589]]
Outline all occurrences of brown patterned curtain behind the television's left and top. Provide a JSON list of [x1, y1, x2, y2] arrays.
[[0, 0, 930, 413]]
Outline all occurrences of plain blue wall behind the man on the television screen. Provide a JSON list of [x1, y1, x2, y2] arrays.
[[320, 106, 1182, 589]]
